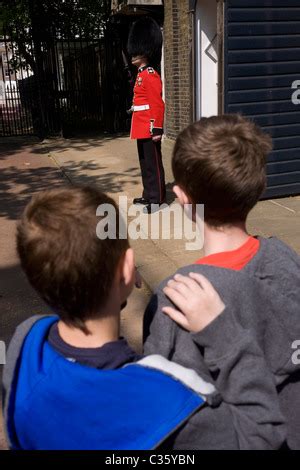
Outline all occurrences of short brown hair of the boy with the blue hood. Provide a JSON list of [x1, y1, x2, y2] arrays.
[[17, 187, 129, 333]]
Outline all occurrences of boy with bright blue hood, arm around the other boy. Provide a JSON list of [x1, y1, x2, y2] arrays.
[[3, 188, 285, 450]]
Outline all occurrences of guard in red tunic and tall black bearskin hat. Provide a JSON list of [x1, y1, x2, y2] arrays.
[[127, 17, 166, 214]]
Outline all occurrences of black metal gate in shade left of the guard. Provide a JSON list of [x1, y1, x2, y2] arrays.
[[0, 28, 130, 137]]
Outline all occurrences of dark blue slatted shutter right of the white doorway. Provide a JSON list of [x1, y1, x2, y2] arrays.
[[224, 0, 300, 197]]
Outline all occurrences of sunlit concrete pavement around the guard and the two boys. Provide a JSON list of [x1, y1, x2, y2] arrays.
[[0, 135, 300, 448]]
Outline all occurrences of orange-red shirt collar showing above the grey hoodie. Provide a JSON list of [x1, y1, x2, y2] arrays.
[[195, 237, 260, 271]]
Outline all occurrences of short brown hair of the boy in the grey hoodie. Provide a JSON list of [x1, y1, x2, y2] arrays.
[[172, 114, 272, 226]]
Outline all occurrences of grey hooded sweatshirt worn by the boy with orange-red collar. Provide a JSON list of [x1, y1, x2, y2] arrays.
[[144, 238, 300, 449]]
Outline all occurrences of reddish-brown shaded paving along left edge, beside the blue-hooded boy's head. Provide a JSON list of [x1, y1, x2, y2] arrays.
[[0, 139, 65, 449]]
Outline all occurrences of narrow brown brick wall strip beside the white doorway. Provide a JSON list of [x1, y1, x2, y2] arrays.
[[164, 0, 193, 139]]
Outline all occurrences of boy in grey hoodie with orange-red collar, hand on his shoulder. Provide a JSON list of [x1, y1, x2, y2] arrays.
[[144, 115, 300, 449]]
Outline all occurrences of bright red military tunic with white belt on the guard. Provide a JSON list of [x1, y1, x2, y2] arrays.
[[130, 66, 165, 139]]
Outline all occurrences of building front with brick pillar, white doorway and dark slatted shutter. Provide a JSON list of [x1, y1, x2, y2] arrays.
[[164, 0, 300, 197]]
